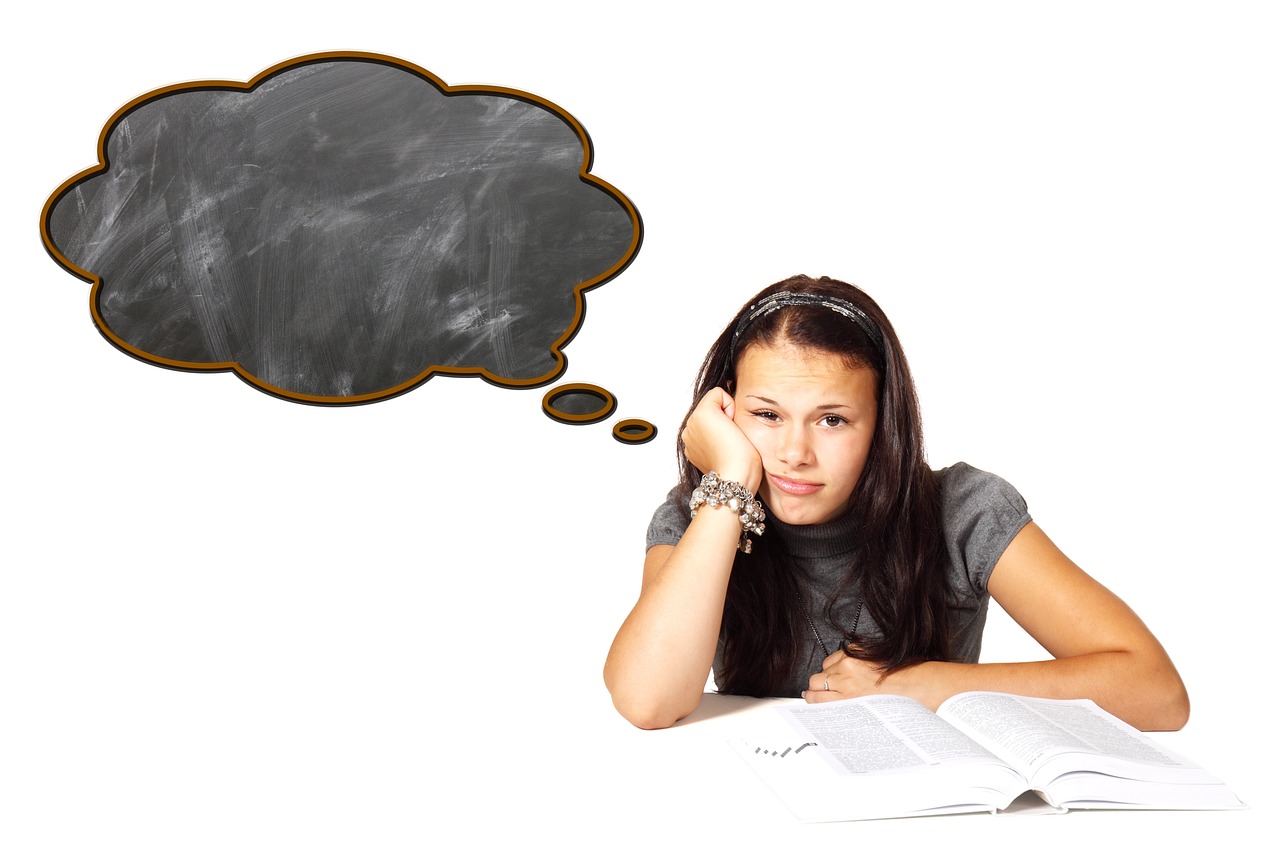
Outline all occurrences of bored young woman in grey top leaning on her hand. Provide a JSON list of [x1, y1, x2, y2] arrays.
[[604, 275, 1189, 730]]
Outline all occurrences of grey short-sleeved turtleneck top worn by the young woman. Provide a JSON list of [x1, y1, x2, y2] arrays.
[[645, 462, 1030, 695]]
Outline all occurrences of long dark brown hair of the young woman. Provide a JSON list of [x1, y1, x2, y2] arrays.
[[676, 275, 950, 695]]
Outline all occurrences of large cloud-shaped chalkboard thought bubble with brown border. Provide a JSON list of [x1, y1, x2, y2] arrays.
[[41, 53, 641, 405]]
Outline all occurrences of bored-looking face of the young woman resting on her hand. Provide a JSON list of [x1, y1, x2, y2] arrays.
[[733, 342, 878, 524]]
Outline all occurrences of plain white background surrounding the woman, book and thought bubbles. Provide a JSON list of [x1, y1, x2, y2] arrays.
[[0, 0, 1280, 850]]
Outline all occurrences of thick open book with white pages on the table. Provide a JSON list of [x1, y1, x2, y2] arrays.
[[731, 692, 1244, 821]]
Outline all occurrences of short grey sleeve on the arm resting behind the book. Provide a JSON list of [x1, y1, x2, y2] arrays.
[[938, 462, 1032, 596]]
